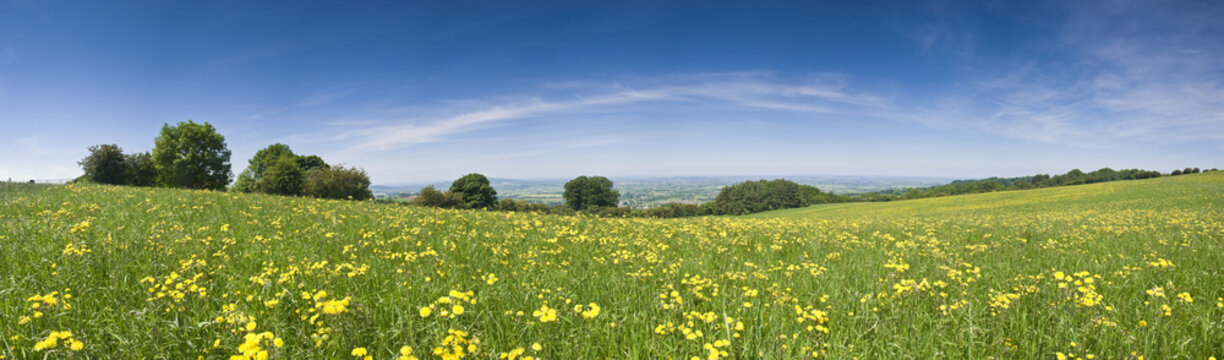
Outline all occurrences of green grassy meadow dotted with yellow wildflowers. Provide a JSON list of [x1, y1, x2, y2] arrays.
[[0, 173, 1224, 359]]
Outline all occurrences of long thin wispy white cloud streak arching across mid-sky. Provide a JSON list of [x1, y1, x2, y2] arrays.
[[310, 73, 887, 152]]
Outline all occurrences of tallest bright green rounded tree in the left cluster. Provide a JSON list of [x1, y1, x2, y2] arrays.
[[153, 120, 231, 190]]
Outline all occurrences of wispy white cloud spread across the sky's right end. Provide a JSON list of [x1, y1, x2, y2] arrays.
[[898, 1, 1224, 147]]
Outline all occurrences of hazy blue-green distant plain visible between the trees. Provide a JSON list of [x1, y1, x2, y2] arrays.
[[370, 175, 956, 208]]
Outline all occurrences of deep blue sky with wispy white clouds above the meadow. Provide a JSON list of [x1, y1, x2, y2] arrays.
[[0, 0, 1224, 184]]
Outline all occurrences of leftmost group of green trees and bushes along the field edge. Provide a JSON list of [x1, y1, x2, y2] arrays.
[[73, 120, 373, 200]]
